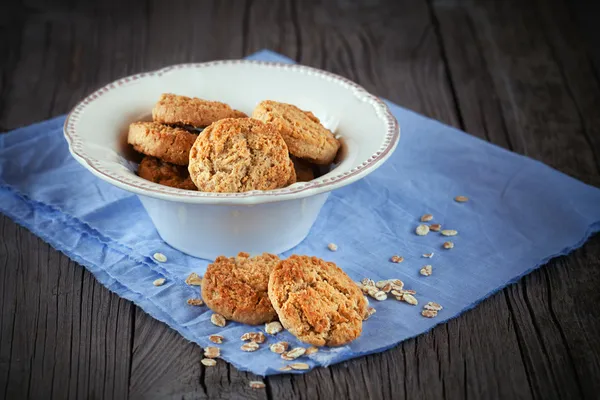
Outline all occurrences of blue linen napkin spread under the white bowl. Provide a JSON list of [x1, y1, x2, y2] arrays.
[[0, 51, 600, 375]]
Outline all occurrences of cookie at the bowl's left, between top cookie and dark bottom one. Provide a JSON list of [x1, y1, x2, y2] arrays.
[[127, 122, 198, 165]]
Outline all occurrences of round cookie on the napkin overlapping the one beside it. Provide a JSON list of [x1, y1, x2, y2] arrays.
[[269, 255, 367, 346]]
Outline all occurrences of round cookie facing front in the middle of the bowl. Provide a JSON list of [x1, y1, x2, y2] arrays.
[[188, 118, 296, 193]]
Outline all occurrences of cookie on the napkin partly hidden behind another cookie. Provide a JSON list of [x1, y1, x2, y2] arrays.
[[202, 253, 279, 325]]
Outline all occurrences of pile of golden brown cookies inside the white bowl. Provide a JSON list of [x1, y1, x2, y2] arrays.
[[128, 94, 340, 193]]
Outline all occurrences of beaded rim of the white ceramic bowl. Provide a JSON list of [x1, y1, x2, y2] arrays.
[[63, 59, 400, 205]]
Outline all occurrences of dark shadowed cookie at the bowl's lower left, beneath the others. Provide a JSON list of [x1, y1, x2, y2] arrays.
[[138, 156, 198, 190]]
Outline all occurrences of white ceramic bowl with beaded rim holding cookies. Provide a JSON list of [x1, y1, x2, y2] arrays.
[[64, 60, 400, 259]]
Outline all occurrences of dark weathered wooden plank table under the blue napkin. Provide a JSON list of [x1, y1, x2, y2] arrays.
[[0, 0, 600, 399]]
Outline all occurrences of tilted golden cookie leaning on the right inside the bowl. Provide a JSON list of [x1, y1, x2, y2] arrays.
[[252, 100, 340, 165]]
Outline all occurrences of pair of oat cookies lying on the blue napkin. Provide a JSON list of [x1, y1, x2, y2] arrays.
[[202, 253, 368, 346]]
